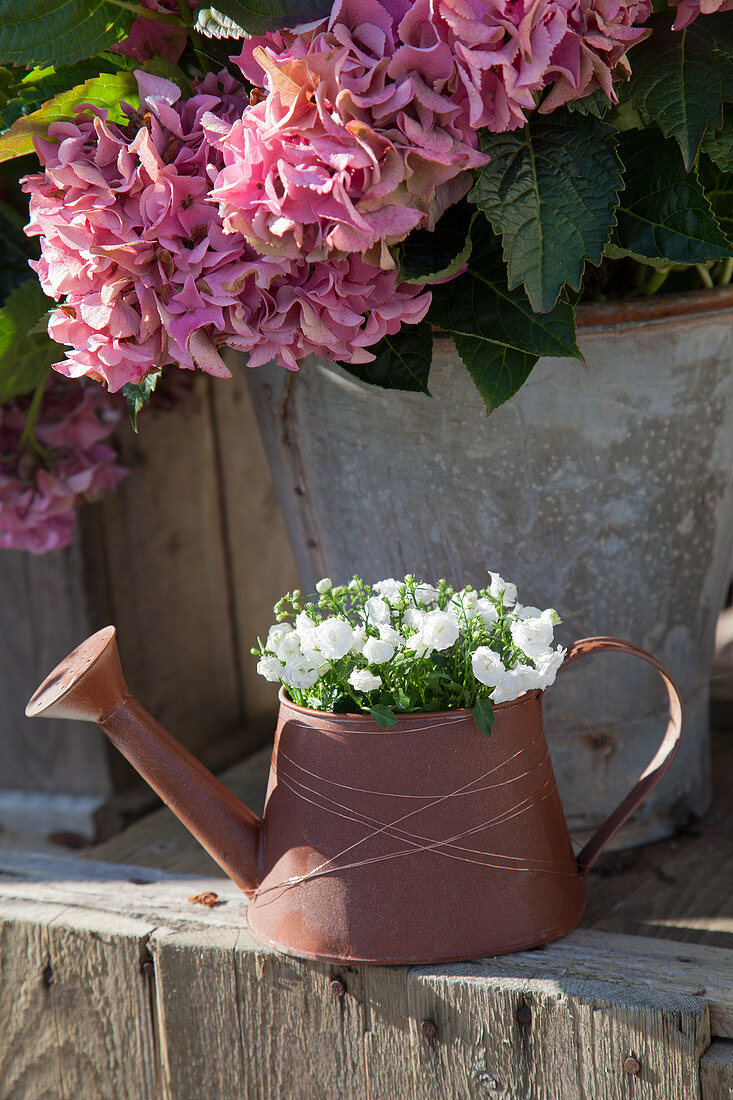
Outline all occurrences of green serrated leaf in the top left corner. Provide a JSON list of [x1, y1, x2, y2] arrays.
[[0, 0, 135, 65]]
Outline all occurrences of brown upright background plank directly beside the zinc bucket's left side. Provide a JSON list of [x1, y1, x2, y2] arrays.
[[211, 365, 299, 719]]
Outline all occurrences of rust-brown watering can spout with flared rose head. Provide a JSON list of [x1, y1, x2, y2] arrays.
[[25, 626, 261, 893]]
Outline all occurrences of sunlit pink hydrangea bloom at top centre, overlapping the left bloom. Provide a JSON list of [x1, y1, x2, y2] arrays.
[[212, 0, 486, 267]]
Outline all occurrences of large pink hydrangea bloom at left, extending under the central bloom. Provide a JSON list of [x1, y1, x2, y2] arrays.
[[24, 72, 430, 392]]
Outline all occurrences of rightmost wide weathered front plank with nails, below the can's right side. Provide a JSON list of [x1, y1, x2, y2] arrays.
[[364, 960, 710, 1100]]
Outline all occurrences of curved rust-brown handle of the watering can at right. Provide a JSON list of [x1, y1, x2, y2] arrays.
[[560, 638, 682, 875]]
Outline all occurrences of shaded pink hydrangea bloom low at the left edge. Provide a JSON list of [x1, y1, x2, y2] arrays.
[[0, 380, 128, 553]]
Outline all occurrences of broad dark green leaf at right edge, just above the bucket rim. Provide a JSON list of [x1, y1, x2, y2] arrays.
[[612, 127, 733, 264]]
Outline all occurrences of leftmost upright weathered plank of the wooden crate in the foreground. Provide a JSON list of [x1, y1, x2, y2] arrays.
[[0, 900, 157, 1100]]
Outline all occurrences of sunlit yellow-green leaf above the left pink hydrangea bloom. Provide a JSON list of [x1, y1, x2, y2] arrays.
[[0, 73, 139, 161]]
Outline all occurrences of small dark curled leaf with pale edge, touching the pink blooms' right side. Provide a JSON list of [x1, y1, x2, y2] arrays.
[[400, 202, 477, 284]]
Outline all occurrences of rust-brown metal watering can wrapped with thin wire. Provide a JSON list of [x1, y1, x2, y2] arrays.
[[25, 627, 682, 964]]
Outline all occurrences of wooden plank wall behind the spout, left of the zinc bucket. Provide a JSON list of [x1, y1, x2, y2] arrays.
[[0, 367, 297, 832]]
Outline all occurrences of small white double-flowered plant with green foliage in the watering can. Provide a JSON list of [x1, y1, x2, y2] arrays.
[[252, 573, 566, 736]]
